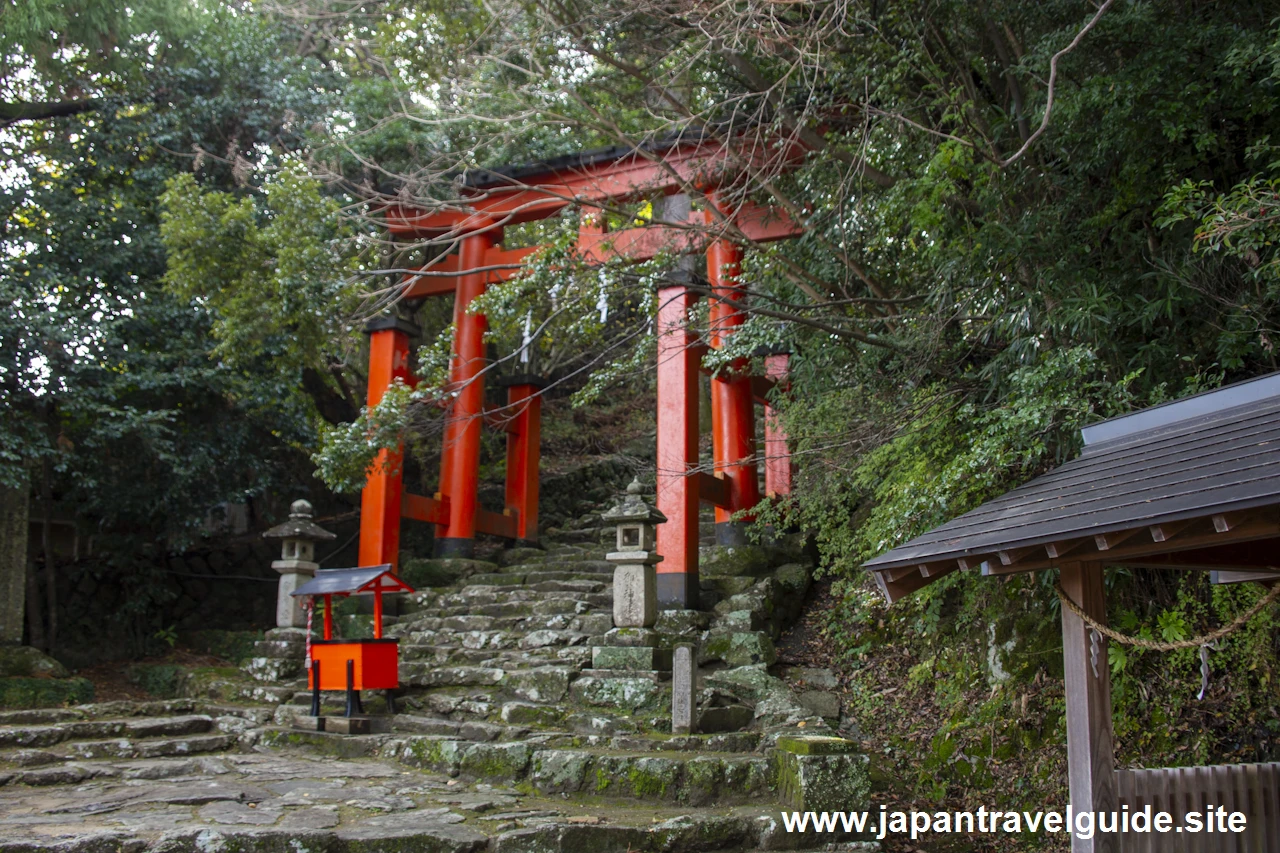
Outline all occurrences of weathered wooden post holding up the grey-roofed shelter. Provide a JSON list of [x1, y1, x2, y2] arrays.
[[1061, 562, 1120, 853]]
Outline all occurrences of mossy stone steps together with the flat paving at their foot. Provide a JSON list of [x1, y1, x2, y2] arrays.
[[0, 522, 879, 853]]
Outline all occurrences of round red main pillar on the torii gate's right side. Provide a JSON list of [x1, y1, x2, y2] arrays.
[[707, 193, 760, 546]]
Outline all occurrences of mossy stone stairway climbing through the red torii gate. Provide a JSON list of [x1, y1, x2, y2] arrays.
[[249, 544, 865, 806]]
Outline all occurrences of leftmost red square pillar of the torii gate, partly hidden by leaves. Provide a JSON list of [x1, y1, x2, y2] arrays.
[[360, 316, 417, 567]]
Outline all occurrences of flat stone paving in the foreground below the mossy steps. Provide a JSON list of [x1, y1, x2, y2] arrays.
[[0, 732, 874, 853]]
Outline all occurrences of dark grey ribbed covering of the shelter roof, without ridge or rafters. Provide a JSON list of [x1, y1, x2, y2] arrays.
[[865, 374, 1280, 569]]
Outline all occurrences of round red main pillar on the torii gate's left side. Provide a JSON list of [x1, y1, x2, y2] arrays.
[[435, 231, 498, 557]]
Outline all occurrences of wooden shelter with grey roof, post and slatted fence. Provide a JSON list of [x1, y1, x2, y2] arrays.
[[864, 373, 1280, 853]]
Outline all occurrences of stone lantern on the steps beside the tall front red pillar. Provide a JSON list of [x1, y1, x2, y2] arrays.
[[600, 478, 667, 628]]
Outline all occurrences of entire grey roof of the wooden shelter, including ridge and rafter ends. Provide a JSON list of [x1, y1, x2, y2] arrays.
[[864, 374, 1280, 601]]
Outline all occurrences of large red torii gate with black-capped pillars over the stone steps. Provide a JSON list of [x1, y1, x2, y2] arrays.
[[360, 141, 804, 608]]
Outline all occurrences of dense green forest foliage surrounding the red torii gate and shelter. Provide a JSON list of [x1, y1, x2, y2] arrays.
[[0, 0, 1280, 835]]
